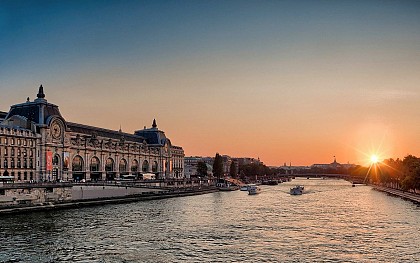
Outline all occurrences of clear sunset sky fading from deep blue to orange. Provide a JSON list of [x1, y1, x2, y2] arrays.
[[0, 0, 420, 165]]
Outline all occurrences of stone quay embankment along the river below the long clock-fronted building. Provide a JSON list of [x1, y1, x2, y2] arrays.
[[0, 182, 217, 215]]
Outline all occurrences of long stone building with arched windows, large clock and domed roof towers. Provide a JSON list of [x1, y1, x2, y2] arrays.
[[0, 85, 184, 182]]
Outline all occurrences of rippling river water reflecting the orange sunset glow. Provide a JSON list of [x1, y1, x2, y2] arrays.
[[0, 179, 420, 262]]
